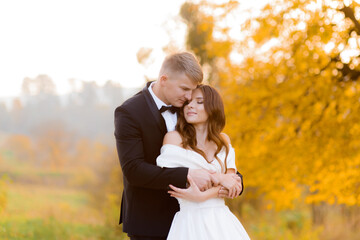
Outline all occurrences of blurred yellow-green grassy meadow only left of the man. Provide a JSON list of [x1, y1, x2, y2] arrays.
[[0, 147, 127, 240]]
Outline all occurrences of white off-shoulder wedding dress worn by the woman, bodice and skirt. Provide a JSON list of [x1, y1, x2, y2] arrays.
[[156, 144, 250, 240]]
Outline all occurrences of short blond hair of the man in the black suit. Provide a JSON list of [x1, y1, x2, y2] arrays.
[[160, 52, 204, 84]]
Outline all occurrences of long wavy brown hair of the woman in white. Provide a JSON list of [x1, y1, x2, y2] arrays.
[[176, 85, 229, 173]]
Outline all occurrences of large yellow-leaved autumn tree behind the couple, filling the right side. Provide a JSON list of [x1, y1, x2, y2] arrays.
[[181, 0, 360, 213]]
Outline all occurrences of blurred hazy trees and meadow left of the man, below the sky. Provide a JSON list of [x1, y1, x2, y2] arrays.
[[0, 75, 132, 239]]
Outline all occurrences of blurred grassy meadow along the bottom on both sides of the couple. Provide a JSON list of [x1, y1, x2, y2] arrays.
[[0, 141, 360, 240]]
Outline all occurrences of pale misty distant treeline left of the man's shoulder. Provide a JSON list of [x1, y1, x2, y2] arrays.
[[0, 75, 139, 142]]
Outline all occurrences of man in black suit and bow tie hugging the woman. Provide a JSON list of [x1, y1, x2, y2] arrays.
[[115, 52, 245, 240]]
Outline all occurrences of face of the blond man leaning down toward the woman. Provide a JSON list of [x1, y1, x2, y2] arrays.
[[162, 73, 197, 107]]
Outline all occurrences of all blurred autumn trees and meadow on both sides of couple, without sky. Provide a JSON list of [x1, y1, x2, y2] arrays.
[[0, 0, 360, 240]]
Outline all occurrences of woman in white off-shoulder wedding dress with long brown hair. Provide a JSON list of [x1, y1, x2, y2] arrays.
[[157, 85, 250, 240]]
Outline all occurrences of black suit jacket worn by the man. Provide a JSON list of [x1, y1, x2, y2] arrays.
[[115, 84, 188, 237]]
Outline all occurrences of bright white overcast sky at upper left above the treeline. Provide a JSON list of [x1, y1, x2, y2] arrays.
[[0, 0, 191, 97]]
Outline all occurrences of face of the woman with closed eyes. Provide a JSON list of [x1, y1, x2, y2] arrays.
[[184, 89, 209, 124]]
